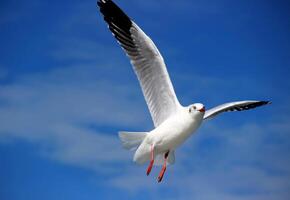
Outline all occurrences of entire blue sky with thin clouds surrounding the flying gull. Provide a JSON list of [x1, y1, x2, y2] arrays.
[[0, 0, 290, 200]]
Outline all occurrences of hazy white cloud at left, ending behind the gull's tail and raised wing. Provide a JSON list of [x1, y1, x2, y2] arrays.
[[0, 63, 150, 173]]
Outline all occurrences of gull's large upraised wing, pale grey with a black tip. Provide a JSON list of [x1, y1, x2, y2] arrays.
[[98, 0, 180, 127]]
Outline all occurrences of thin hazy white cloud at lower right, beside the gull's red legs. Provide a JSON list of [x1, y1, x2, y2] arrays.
[[110, 120, 290, 200]]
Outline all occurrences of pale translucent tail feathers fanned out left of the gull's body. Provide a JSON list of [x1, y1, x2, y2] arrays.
[[119, 131, 147, 150]]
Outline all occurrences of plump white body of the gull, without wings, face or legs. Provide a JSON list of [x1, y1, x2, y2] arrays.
[[134, 107, 204, 164]]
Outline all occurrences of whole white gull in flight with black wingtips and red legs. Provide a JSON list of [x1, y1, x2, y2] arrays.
[[97, 0, 271, 182]]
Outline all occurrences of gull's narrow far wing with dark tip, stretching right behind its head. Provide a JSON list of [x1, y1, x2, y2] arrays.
[[203, 101, 271, 120]]
